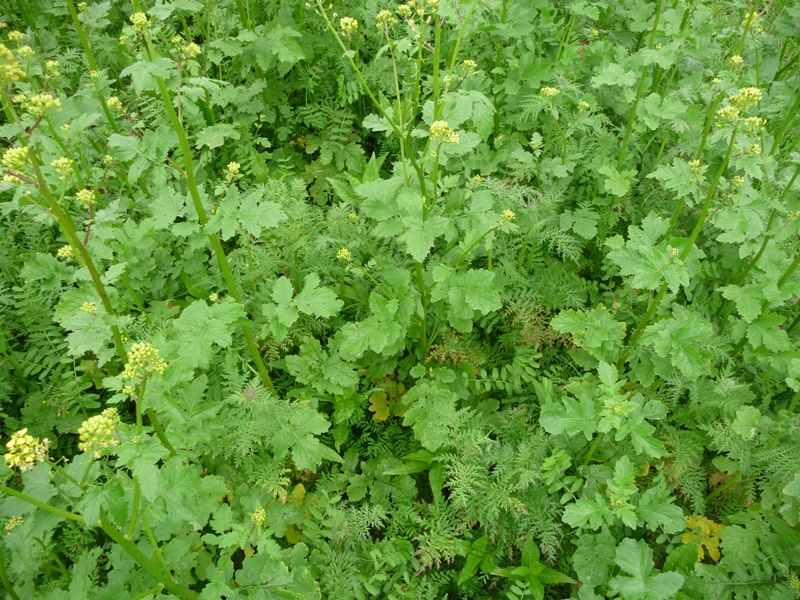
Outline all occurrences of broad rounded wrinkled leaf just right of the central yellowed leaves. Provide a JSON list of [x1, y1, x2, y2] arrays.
[[403, 380, 458, 452]]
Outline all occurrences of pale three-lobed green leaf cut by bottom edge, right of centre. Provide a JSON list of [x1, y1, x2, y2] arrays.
[[608, 538, 683, 600]]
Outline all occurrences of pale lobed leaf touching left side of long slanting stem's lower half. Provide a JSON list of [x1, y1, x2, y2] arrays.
[[173, 300, 245, 369]]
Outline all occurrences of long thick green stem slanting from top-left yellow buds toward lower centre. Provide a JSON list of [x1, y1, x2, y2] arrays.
[[134, 17, 278, 396]]
